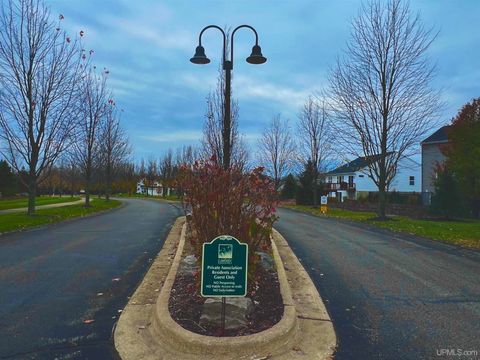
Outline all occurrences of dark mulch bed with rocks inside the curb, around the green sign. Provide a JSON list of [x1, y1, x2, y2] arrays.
[[168, 221, 284, 336]]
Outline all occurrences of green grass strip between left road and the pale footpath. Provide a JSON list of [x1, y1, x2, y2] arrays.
[[0, 199, 121, 233]]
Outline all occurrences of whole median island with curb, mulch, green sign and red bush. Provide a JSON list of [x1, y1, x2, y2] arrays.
[[115, 159, 336, 360]]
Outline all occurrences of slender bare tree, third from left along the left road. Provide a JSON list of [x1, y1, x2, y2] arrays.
[[100, 99, 132, 200]]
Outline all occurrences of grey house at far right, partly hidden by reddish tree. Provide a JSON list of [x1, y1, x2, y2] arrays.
[[421, 125, 451, 205]]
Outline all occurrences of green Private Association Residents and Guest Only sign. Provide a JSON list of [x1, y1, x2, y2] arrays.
[[201, 235, 248, 297]]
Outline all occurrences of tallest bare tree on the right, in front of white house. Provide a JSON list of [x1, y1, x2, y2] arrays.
[[330, 0, 441, 218]]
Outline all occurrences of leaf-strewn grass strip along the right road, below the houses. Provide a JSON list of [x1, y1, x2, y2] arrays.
[[285, 205, 480, 249]]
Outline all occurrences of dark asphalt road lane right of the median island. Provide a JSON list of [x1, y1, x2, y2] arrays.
[[276, 209, 480, 360]]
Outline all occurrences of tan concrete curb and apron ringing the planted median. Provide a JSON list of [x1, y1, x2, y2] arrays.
[[114, 217, 336, 360]]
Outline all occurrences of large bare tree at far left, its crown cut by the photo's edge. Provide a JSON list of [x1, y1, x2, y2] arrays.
[[0, 0, 81, 215]]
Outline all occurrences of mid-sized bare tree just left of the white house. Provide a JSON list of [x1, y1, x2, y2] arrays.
[[298, 96, 333, 206]]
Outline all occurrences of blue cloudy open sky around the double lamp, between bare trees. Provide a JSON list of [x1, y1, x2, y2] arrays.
[[47, 0, 480, 159]]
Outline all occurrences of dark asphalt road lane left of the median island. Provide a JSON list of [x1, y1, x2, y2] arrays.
[[0, 199, 180, 360]]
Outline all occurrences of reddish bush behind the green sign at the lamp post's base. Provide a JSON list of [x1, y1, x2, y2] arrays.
[[177, 158, 277, 263]]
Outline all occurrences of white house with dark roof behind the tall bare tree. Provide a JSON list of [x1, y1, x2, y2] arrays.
[[325, 156, 422, 201]]
